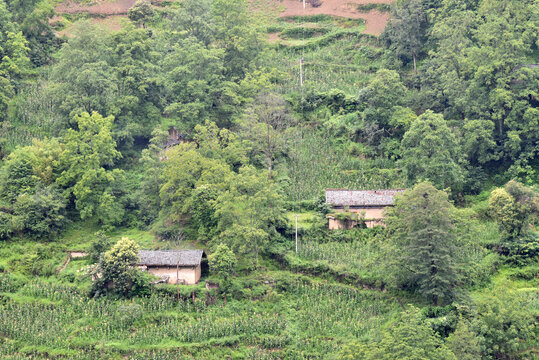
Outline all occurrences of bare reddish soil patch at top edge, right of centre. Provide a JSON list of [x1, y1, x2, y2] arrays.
[[280, 0, 394, 35]]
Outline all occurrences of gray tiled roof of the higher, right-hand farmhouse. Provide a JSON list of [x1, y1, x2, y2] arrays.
[[326, 189, 405, 206]]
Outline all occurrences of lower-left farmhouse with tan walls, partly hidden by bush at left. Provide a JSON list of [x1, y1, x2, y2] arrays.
[[138, 250, 205, 285]]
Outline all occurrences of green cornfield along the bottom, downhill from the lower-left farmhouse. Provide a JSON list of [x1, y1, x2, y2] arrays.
[[0, 281, 391, 360]]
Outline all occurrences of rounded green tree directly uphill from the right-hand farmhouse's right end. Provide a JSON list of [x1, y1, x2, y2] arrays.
[[399, 111, 464, 190]]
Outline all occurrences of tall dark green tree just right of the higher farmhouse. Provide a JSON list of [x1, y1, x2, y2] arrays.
[[386, 183, 457, 305]]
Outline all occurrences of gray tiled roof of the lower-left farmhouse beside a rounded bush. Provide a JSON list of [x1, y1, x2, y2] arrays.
[[138, 250, 204, 266]]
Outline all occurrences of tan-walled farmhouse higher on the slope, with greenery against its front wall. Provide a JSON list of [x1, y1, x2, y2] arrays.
[[326, 189, 405, 230]]
